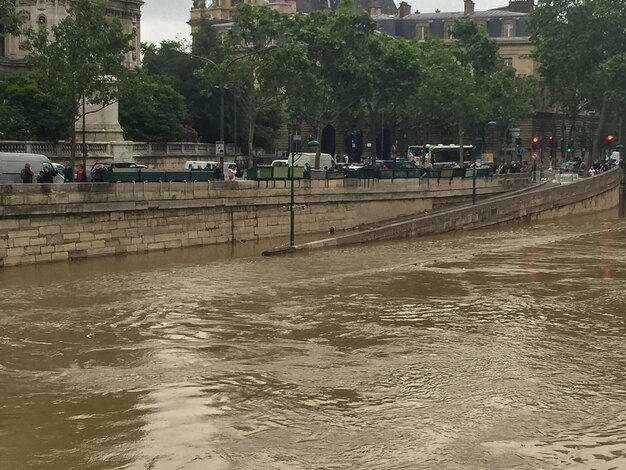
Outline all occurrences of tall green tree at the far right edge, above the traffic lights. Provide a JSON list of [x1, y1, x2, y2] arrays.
[[529, 0, 626, 159]]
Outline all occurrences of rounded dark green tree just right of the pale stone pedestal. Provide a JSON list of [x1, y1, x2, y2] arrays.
[[119, 70, 187, 142]]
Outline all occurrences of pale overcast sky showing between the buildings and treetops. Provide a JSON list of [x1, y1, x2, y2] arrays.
[[141, 0, 509, 44]]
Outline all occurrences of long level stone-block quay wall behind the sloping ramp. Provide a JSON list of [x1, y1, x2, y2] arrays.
[[0, 175, 529, 267]]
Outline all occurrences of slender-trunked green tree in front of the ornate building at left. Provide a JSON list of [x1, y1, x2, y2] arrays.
[[29, 0, 132, 166]]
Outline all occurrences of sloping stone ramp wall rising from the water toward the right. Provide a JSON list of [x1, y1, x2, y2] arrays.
[[297, 169, 621, 250]]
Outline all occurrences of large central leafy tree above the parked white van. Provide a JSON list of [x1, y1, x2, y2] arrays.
[[276, 1, 386, 162]]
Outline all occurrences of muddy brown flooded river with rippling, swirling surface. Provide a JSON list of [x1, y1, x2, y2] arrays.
[[0, 216, 626, 470]]
